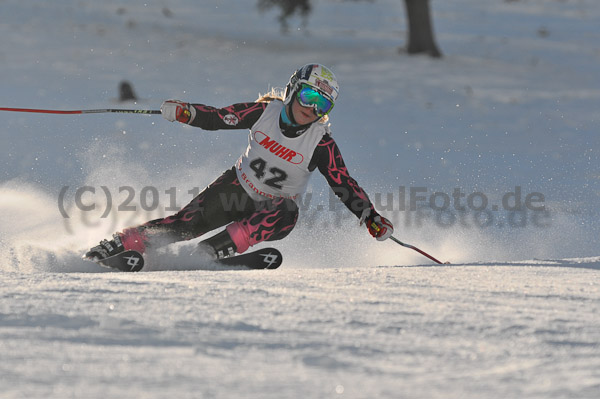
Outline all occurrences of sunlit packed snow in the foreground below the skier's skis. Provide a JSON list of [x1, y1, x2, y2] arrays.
[[0, 258, 600, 399]]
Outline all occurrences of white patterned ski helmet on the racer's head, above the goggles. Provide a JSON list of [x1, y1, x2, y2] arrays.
[[284, 64, 340, 111]]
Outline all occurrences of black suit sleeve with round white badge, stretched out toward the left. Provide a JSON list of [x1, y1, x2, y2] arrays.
[[190, 102, 268, 130]]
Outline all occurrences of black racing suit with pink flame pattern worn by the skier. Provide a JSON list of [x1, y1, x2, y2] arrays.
[[122, 102, 375, 253]]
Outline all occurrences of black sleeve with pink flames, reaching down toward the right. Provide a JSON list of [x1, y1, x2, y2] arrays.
[[311, 135, 375, 218]]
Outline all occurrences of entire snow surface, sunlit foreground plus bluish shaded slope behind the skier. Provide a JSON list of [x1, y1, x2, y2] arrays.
[[0, 0, 600, 398]]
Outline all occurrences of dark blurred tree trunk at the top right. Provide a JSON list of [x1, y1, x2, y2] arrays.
[[404, 0, 442, 58]]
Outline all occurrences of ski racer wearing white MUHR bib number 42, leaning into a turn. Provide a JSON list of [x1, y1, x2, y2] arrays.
[[84, 64, 393, 260]]
